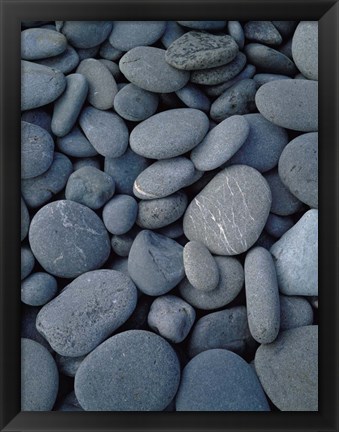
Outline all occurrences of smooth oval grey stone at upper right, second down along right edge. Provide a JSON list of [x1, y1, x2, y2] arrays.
[[255, 80, 318, 132]]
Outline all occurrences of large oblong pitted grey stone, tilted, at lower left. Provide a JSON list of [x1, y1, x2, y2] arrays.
[[36, 270, 137, 357]]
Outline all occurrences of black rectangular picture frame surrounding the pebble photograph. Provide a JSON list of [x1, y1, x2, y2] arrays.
[[0, 0, 339, 432]]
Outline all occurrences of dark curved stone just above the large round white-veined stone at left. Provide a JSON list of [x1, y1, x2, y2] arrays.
[[21, 152, 73, 208]]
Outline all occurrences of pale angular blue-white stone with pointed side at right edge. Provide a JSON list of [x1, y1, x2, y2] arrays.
[[271, 210, 318, 296]]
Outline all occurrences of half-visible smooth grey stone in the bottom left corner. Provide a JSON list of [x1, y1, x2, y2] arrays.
[[21, 338, 59, 411]]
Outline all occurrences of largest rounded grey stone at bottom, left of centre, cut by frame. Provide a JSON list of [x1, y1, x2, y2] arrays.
[[75, 330, 180, 411]]
